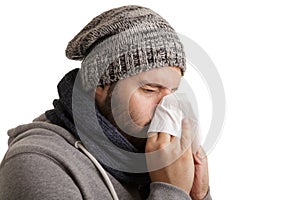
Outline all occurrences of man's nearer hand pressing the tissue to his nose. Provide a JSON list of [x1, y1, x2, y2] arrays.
[[145, 121, 194, 194]]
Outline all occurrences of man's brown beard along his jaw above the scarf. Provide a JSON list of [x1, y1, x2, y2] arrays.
[[97, 83, 150, 152]]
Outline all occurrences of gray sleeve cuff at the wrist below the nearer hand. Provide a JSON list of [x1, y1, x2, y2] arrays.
[[148, 182, 191, 200]]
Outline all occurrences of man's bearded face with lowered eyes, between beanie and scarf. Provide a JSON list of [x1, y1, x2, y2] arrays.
[[96, 67, 181, 151]]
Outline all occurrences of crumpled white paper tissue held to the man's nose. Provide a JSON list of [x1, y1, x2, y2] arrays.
[[148, 93, 201, 153]]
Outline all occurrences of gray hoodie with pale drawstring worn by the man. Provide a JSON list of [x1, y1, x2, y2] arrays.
[[0, 114, 211, 200]]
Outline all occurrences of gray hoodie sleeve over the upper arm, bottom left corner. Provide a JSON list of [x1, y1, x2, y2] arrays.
[[0, 153, 83, 200]]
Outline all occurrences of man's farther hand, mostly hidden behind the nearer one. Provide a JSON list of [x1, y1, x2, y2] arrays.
[[190, 147, 209, 200]]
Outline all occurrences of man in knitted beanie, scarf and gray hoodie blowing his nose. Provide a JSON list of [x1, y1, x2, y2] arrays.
[[0, 6, 211, 200]]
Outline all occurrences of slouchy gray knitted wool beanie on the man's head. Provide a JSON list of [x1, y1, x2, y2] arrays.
[[66, 6, 186, 90]]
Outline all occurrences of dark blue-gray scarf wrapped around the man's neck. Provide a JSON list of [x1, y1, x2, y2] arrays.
[[45, 69, 150, 196]]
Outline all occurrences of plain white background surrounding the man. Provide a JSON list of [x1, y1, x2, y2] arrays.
[[0, 0, 300, 200]]
